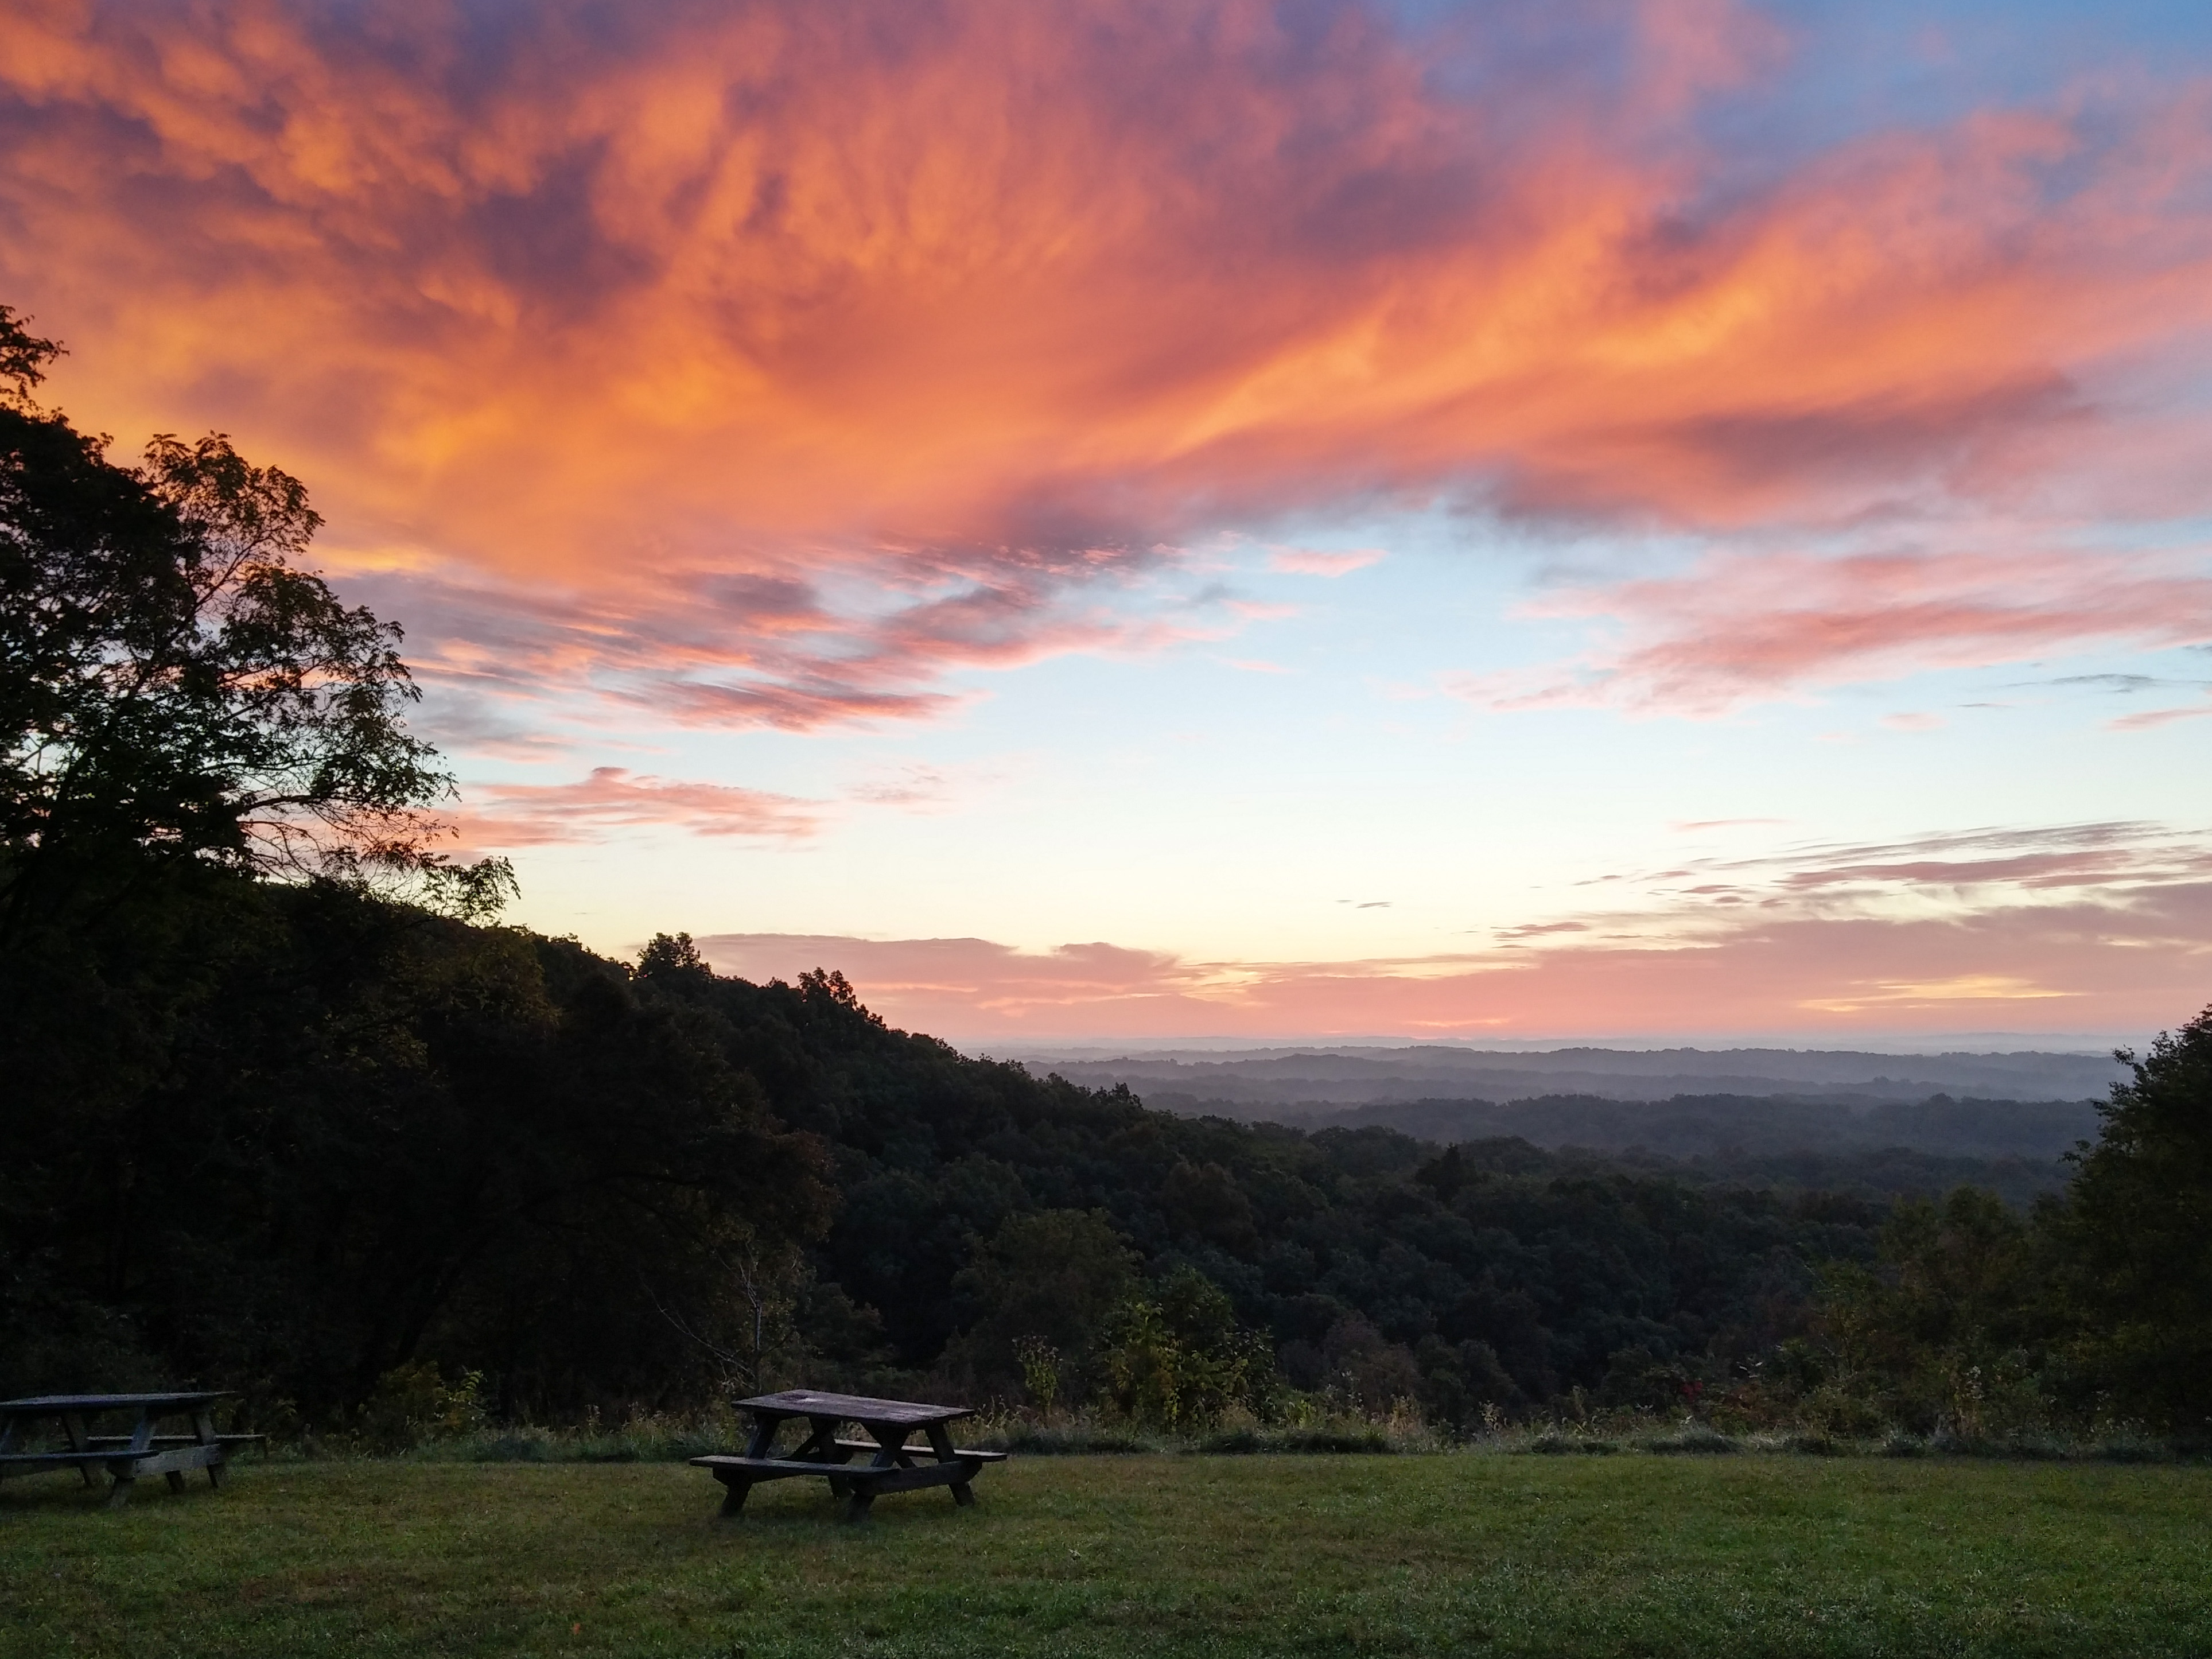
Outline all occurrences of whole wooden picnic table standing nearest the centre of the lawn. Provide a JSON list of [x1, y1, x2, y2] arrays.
[[690, 1389, 1006, 1522]]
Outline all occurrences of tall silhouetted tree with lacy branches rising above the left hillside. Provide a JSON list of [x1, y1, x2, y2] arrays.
[[0, 305, 487, 934]]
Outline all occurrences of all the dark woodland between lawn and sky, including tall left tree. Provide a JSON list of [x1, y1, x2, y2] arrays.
[[0, 308, 2212, 1433]]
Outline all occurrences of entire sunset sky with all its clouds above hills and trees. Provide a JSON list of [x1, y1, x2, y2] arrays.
[[0, 0, 2212, 1046]]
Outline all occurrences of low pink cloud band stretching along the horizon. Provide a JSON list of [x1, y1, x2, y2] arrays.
[[701, 898, 2212, 1042]]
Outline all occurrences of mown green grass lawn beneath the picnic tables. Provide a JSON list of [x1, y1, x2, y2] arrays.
[[0, 1454, 2212, 1659]]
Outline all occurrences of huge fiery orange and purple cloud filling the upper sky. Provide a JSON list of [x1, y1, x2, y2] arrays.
[[0, 0, 2212, 725]]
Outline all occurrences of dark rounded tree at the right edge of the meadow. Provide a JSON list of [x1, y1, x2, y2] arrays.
[[2051, 1009, 2212, 1431]]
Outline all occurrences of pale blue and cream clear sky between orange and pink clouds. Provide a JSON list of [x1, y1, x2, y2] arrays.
[[493, 498, 2212, 960]]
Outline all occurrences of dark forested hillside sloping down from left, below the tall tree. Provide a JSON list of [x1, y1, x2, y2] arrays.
[[0, 898, 1880, 1420]]
